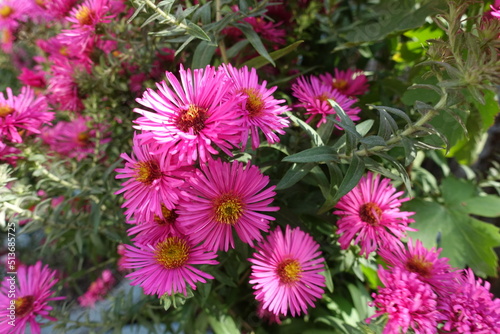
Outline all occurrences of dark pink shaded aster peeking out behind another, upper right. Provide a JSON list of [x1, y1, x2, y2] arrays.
[[319, 68, 368, 97]]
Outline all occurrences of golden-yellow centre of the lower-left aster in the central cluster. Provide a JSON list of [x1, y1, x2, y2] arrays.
[[155, 237, 190, 269]]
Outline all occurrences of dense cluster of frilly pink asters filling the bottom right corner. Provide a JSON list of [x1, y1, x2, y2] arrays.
[[367, 239, 500, 334]]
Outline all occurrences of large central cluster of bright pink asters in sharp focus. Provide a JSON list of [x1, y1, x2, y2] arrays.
[[116, 65, 324, 317]]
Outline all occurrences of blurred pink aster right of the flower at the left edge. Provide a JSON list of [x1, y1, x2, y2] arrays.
[[41, 116, 110, 161]]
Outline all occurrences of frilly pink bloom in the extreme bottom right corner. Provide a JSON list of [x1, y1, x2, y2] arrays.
[[443, 269, 500, 334]]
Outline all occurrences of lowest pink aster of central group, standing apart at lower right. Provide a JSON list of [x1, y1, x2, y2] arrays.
[[249, 225, 325, 316]]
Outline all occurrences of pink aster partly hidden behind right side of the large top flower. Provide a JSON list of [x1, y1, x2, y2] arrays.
[[224, 65, 289, 150]]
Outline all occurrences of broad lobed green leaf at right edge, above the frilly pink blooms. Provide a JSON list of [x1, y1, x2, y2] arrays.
[[405, 177, 500, 277]]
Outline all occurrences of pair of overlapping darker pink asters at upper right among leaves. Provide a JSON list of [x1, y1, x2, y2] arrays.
[[292, 69, 368, 127]]
